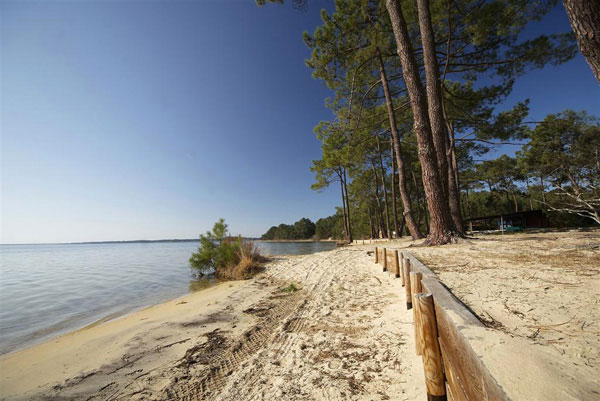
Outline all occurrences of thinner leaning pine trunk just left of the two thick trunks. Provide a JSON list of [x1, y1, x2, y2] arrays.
[[376, 48, 423, 239]]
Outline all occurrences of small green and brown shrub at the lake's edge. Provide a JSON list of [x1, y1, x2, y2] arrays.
[[190, 219, 265, 280]]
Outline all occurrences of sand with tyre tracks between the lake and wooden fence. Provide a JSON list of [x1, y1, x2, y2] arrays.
[[0, 246, 426, 400]]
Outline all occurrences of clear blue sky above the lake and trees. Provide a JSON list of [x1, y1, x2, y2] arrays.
[[0, 0, 600, 243]]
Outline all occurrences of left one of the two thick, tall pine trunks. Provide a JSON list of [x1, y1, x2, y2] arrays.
[[386, 0, 453, 245]]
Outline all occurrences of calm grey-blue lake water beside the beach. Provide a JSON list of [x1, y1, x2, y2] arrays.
[[0, 241, 335, 355]]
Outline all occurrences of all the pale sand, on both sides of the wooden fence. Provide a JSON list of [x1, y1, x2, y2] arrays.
[[0, 231, 600, 401]]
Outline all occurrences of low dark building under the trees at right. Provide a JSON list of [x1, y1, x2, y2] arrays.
[[465, 210, 549, 231]]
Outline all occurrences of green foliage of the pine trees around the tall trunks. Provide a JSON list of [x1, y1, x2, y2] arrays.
[[257, 0, 588, 233]]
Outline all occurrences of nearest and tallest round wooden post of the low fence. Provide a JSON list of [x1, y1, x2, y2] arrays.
[[415, 294, 447, 401]]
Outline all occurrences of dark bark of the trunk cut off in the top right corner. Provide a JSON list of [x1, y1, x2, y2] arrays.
[[563, 0, 600, 82]]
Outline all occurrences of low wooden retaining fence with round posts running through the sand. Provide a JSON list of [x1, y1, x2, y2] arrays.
[[375, 247, 510, 401]]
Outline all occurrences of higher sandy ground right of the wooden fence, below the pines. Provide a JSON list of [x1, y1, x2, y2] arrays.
[[392, 230, 600, 401]]
